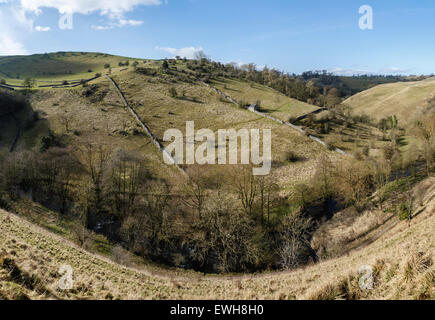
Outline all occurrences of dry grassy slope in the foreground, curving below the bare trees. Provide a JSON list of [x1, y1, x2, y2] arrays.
[[0, 178, 435, 299]]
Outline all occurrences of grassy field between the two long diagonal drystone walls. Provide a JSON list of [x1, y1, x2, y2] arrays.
[[106, 70, 340, 189]]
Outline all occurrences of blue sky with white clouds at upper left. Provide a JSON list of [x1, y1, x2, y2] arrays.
[[0, 0, 435, 75]]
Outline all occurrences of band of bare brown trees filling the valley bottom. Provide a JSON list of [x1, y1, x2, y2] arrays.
[[0, 124, 435, 272]]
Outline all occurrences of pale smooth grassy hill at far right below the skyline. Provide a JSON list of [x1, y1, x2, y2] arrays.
[[344, 78, 435, 126]]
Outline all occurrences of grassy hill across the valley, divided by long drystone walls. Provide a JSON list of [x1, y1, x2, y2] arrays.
[[0, 52, 350, 190]]
